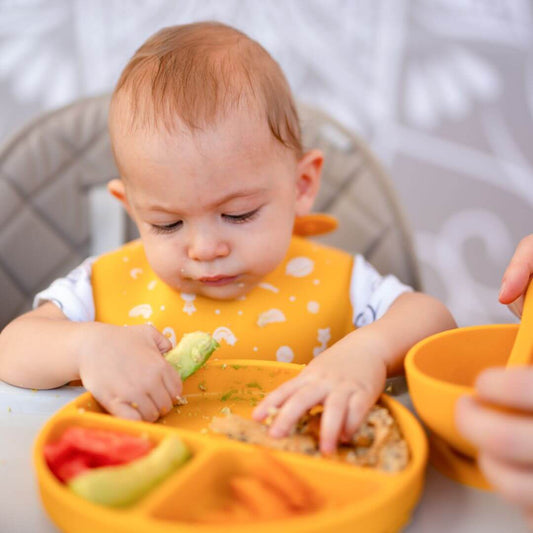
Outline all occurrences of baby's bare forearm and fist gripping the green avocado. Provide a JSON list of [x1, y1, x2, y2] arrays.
[[0, 302, 181, 421]]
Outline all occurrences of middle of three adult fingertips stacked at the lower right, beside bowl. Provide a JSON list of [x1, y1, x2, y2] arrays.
[[456, 397, 533, 468]]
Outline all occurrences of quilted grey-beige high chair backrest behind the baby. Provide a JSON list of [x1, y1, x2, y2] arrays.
[[0, 95, 420, 327]]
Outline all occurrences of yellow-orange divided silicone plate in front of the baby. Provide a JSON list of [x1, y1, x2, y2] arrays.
[[34, 360, 428, 533]]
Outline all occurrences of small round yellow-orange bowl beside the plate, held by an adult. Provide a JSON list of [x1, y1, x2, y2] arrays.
[[405, 324, 518, 458]]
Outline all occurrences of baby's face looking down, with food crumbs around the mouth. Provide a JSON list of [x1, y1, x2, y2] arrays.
[[110, 108, 303, 299]]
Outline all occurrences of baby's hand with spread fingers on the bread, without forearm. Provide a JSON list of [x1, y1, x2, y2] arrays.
[[253, 331, 386, 454]]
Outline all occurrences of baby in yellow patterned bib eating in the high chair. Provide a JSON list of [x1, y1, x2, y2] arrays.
[[0, 23, 455, 453]]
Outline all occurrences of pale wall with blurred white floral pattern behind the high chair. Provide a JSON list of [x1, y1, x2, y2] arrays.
[[0, 0, 533, 325]]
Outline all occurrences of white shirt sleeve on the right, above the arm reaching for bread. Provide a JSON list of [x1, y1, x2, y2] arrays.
[[350, 254, 413, 328]]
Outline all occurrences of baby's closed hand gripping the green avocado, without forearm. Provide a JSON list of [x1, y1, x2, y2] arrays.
[[78, 323, 182, 422]]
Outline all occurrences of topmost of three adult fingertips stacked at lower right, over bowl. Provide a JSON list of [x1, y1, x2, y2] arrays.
[[476, 367, 533, 415]]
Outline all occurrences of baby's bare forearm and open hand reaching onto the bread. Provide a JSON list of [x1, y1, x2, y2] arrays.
[[254, 292, 455, 453]]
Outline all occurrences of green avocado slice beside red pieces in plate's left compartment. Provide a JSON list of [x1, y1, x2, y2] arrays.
[[68, 435, 191, 507]]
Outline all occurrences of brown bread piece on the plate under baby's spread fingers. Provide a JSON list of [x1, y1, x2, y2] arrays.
[[209, 404, 409, 472]]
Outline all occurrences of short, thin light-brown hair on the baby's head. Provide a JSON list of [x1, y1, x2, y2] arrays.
[[111, 22, 302, 157]]
